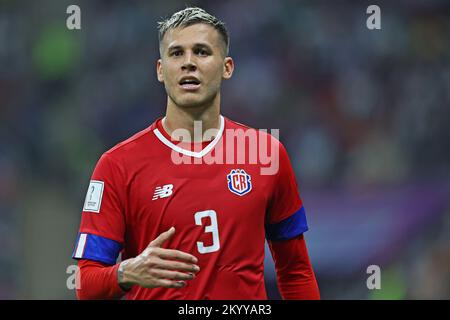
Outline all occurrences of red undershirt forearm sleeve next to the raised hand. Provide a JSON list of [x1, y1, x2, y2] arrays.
[[77, 259, 126, 300]]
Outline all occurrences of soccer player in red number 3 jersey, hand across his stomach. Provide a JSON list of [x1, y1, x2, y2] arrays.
[[73, 8, 319, 299]]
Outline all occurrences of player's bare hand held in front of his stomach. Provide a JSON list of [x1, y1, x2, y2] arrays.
[[118, 227, 200, 288]]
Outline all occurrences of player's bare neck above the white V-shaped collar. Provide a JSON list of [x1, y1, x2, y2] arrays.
[[162, 94, 220, 142]]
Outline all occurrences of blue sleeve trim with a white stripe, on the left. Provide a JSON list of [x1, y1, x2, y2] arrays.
[[72, 233, 122, 265]]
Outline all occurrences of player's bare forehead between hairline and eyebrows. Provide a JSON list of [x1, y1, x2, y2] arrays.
[[162, 23, 222, 48]]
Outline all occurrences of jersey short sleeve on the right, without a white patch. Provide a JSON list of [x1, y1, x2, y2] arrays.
[[266, 142, 308, 240]]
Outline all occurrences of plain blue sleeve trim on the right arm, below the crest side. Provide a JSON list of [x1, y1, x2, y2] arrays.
[[266, 206, 308, 241]]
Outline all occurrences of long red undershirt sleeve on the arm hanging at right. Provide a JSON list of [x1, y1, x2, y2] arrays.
[[269, 234, 320, 300]]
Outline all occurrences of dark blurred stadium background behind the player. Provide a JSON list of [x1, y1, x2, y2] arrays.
[[0, 0, 450, 299]]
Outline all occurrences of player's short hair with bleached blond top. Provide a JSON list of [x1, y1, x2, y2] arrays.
[[158, 7, 230, 55]]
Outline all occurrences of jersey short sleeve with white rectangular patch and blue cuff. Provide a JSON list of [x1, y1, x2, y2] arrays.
[[72, 153, 125, 265]]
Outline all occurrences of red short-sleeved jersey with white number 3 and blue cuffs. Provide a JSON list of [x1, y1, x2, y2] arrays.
[[73, 116, 308, 299]]
